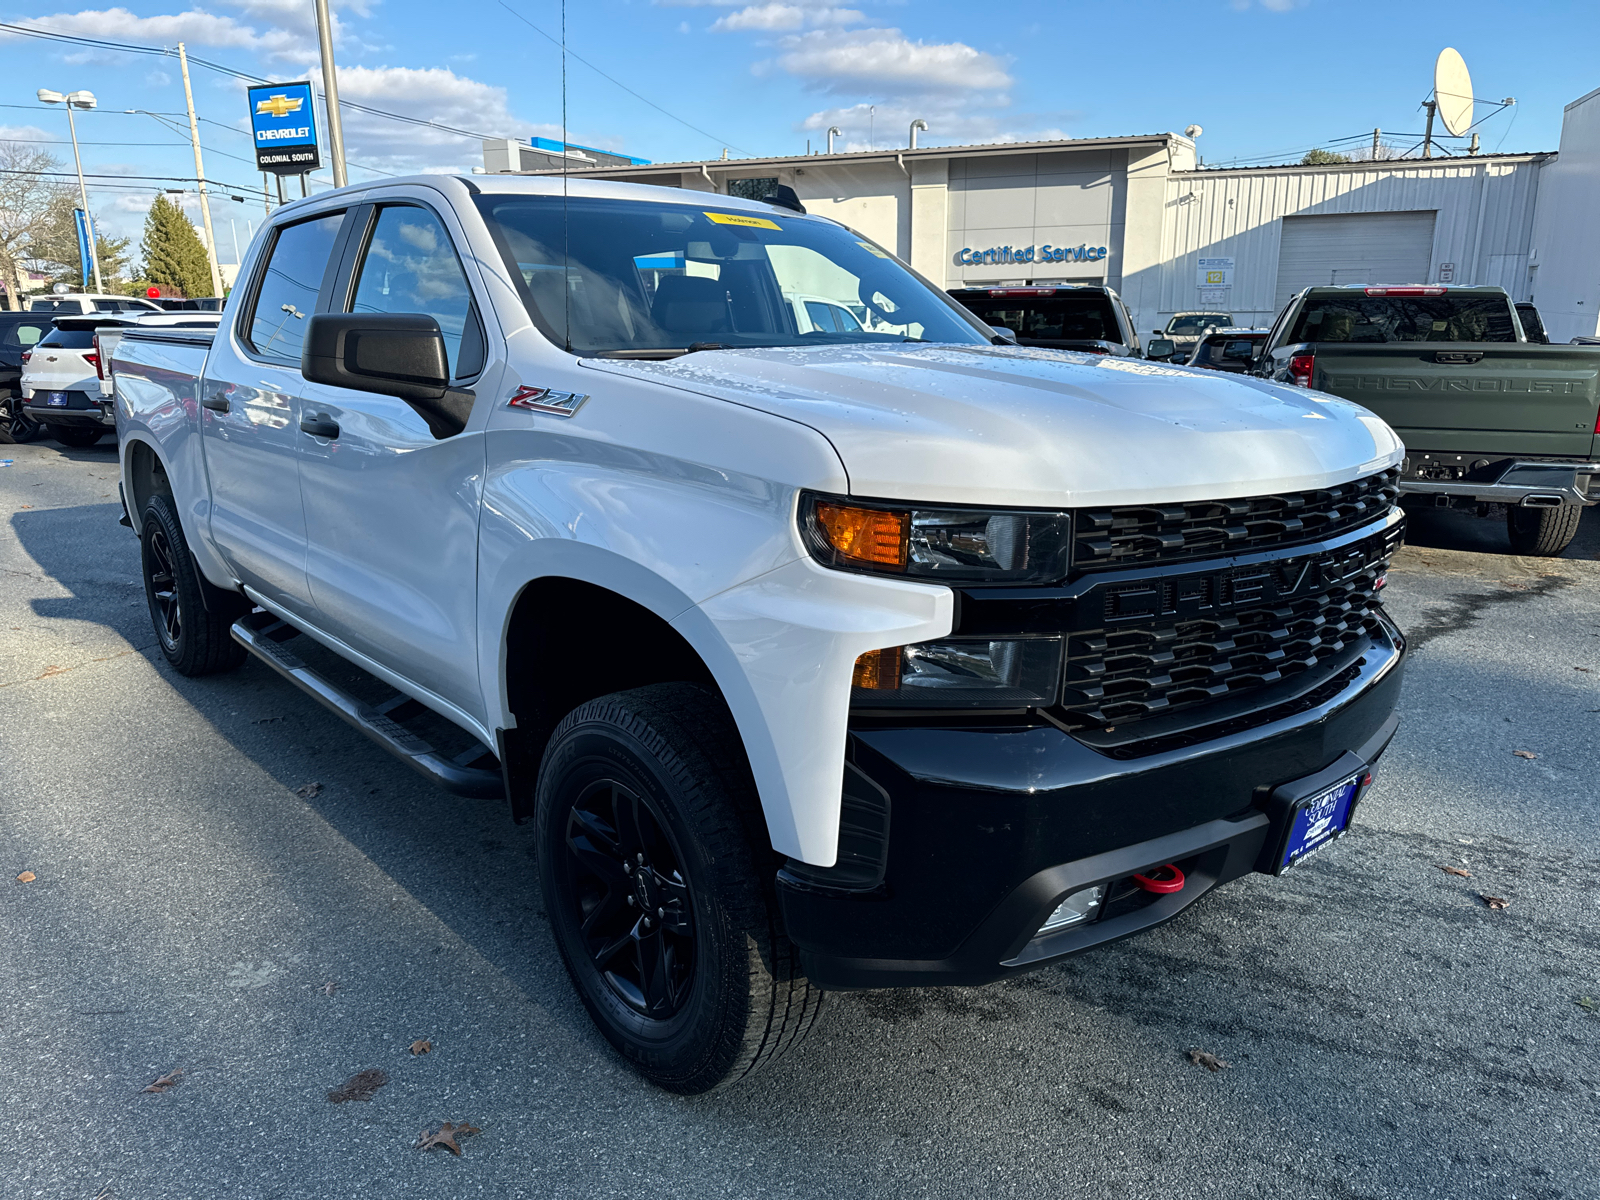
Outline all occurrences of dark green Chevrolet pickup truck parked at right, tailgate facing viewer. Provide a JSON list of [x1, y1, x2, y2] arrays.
[[1256, 286, 1600, 555]]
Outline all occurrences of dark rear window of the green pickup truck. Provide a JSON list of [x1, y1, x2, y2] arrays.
[[1290, 294, 1517, 342]]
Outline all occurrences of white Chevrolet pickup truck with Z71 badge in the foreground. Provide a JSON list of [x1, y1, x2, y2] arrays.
[[112, 176, 1403, 1093]]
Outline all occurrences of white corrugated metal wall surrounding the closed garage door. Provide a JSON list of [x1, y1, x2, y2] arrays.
[[1141, 155, 1547, 328]]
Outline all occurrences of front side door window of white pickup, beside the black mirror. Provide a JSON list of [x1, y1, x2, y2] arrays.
[[350, 205, 483, 379]]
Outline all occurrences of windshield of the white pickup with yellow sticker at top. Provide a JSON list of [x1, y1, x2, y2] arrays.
[[478, 195, 989, 357]]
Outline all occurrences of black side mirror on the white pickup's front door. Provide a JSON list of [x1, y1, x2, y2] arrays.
[[301, 312, 474, 438]]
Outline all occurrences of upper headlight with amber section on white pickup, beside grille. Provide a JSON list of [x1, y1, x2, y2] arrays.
[[800, 493, 1072, 584]]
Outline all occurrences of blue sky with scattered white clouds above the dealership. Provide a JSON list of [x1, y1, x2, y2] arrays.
[[0, 0, 1600, 261]]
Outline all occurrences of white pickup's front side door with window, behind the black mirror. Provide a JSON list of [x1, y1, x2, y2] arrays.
[[298, 198, 498, 720]]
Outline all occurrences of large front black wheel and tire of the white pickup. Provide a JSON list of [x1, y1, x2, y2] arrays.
[[534, 683, 822, 1094]]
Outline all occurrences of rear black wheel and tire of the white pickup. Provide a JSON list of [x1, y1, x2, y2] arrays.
[[139, 493, 250, 675]]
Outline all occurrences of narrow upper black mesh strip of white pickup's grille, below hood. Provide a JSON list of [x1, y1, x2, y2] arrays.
[[1072, 467, 1400, 571]]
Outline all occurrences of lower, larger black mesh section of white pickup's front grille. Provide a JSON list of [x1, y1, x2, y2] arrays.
[[1062, 528, 1400, 728]]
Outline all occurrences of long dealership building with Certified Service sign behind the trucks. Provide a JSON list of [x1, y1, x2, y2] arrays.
[[485, 90, 1600, 341]]
